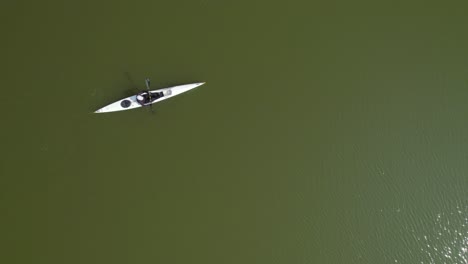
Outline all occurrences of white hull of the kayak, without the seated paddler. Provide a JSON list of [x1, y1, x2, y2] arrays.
[[94, 82, 205, 113]]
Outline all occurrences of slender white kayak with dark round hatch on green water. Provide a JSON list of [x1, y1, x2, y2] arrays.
[[94, 82, 205, 113]]
